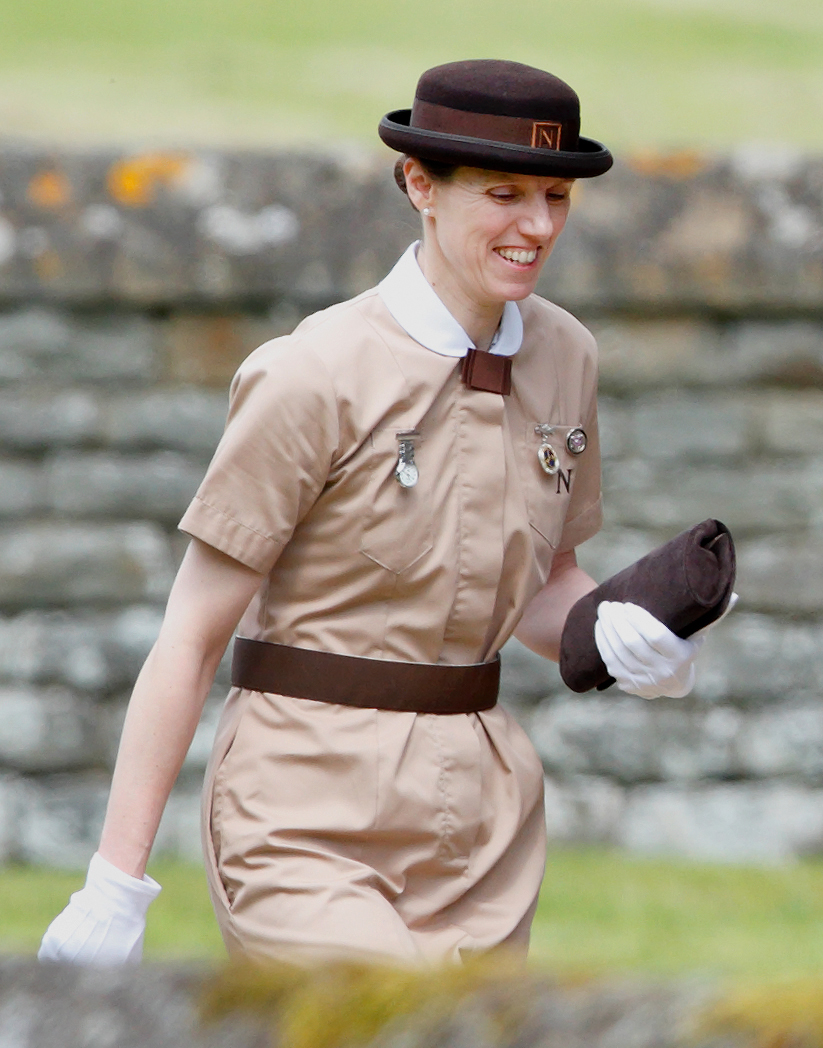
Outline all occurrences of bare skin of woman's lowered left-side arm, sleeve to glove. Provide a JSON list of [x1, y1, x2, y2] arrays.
[[100, 539, 262, 877]]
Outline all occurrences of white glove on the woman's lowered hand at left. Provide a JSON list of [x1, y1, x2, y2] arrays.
[[37, 852, 160, 965]]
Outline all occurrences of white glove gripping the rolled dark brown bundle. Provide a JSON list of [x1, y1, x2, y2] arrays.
[[594, 601, 705, 699]]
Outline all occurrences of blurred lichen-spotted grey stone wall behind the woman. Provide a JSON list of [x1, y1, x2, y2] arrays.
[[0, 147, 823, 866]]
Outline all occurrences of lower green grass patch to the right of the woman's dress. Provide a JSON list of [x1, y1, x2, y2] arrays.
[[532, 850, 823, 979]]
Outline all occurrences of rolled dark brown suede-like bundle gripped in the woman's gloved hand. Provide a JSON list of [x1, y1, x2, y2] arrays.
[[560, 520, 735, 692]]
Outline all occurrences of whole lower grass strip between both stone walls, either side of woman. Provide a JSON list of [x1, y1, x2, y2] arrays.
[[0, 849, 823, 980]]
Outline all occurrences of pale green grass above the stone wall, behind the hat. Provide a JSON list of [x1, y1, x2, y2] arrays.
[[0, 0, 823, 149]]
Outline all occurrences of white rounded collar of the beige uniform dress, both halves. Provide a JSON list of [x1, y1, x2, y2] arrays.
[[377, 240, 523, 356]]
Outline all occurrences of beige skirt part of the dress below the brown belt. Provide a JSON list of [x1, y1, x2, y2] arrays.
[[207, 690, 545, 962]]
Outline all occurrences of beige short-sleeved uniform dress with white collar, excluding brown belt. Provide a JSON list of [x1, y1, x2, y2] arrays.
[[180, 245, 601, 962]]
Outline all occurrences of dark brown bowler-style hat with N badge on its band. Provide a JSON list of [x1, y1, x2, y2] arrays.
[[377, 59, 613, 178]]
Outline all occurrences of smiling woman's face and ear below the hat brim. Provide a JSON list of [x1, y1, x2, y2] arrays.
[[407, 160, 572, 308]]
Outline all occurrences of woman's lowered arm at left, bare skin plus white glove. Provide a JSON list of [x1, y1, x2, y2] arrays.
[[38, 539, 263, 964]]
